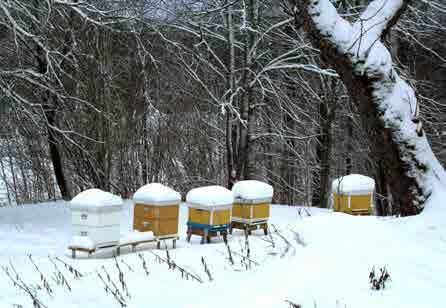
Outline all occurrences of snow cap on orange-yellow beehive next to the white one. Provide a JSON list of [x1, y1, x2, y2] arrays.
[[133, 183, 181, 204]]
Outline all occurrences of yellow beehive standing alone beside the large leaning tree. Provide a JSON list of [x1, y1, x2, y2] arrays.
[[332, 174, 375, 215]]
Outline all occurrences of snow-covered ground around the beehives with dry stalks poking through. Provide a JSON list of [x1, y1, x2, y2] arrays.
[[0, 203, 446, 308]]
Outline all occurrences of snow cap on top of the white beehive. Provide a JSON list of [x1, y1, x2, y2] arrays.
[[70, 188, 123, 211]]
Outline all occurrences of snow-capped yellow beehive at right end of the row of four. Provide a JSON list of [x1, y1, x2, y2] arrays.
[[232, 180, 274, 224]]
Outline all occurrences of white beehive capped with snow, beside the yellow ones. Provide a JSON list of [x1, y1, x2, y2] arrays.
[[71, 189, 123, 248]]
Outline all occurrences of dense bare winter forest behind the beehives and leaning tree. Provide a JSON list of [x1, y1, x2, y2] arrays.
[[0, 0, 446, 215]]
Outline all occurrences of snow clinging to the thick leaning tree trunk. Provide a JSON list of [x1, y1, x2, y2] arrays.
[[308, 0, 446, 211]]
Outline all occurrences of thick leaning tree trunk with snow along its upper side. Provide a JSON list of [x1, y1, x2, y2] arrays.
[[291, 0, 445, 215]]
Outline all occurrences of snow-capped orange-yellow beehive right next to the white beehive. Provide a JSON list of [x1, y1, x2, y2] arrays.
[[133, 183, 181, 238]]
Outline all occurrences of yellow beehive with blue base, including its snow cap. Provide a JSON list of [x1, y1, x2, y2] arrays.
[[186, 186, 234, 242]]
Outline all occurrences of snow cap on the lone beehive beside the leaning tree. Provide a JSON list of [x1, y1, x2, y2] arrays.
[[331, 174, 375, 194]]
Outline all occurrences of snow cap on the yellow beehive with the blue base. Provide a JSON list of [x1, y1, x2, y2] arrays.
[[186, 185, 234, 207]]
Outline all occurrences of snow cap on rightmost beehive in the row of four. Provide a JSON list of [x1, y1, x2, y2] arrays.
[[232, 180, 274, 200]]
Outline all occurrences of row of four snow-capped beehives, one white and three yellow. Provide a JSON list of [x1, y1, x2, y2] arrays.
[[71, 180, 273, 250]]
